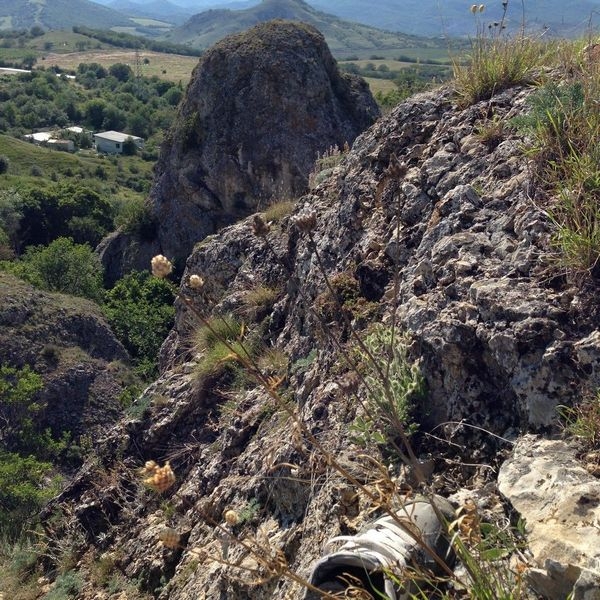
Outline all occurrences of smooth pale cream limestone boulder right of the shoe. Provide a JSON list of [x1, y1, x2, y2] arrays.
[[498, 436, 600, 600]]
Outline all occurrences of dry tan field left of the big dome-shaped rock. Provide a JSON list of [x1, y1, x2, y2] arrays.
[[39, 48, 198, 84]]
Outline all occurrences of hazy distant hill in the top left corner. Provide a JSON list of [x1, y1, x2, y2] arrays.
[[0, 0, 135, 29]]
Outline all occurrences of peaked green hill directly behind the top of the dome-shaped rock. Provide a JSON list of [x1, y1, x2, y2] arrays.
[[165, 0, 434, 58]]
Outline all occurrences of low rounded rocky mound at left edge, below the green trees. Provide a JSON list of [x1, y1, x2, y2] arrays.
[[0, 273, 131, 438]]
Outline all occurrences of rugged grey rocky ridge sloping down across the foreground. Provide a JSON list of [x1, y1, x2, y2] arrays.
[[39, 74, 600, 600]]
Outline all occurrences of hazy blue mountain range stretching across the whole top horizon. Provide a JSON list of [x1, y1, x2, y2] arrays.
[[0, 0, 600, 38]]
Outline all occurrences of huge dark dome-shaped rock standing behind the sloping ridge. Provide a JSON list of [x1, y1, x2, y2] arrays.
[[151, 21, 379, 263]]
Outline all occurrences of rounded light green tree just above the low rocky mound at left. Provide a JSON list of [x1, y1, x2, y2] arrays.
[[7, 238, 104, 302]]
